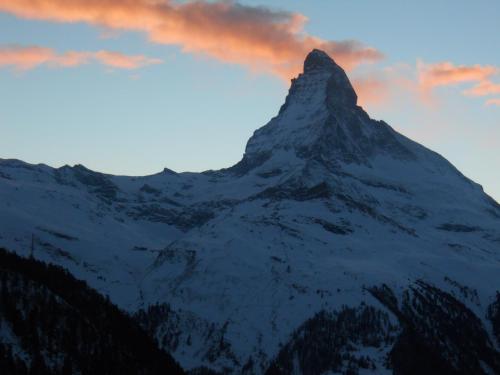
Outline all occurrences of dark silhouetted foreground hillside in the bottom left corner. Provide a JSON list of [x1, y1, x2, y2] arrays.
[[0, 249, 184, 375]]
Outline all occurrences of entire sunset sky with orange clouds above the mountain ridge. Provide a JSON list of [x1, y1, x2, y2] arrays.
[[0, 0, 500, 201]]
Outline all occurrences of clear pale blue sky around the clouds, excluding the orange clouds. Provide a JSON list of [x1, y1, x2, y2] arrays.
[[0, 0, 500, 201]]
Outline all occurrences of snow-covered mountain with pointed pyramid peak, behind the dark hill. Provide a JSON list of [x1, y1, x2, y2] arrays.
[[0, 50, 500, 374]]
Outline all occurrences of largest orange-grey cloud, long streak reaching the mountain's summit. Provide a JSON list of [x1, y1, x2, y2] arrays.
[[0, 0, 382, 79]]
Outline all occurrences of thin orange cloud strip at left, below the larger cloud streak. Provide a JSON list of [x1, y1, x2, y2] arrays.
[[0, 46, 161, 70]]
